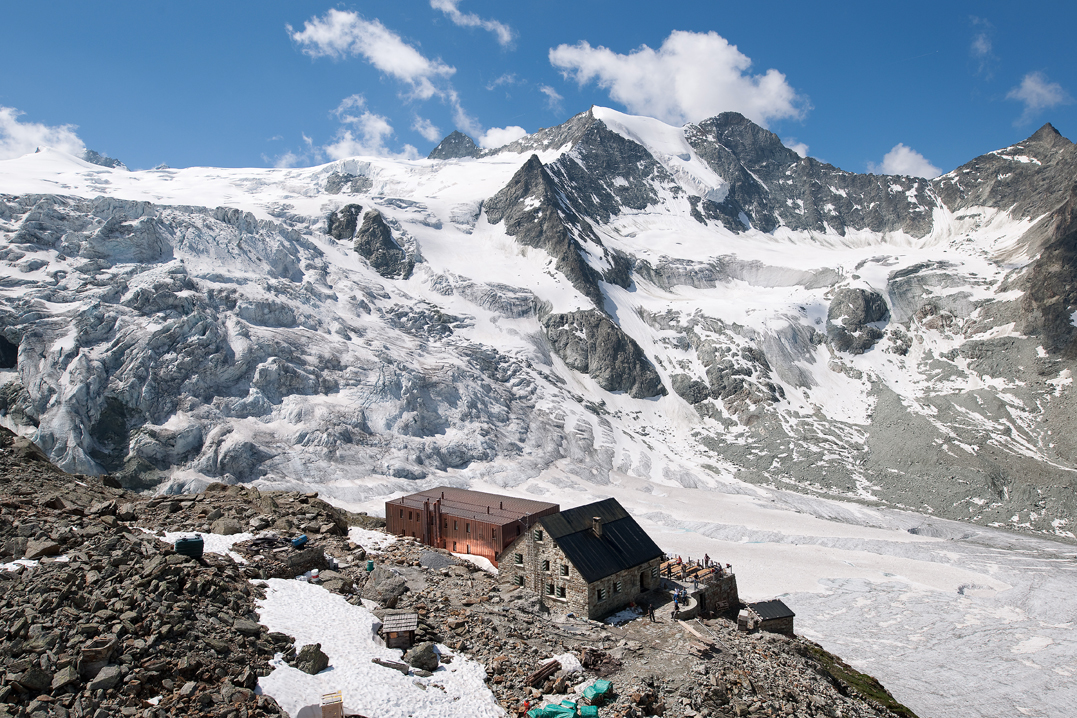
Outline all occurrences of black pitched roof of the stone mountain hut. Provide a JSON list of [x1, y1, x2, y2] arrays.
[[539, 498, 662, 583]]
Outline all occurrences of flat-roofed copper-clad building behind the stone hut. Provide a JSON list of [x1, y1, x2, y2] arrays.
[[386, 487, 561, 565]]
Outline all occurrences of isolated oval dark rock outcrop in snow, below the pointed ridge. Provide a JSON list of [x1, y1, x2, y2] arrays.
[[543, 310, 666, 398]]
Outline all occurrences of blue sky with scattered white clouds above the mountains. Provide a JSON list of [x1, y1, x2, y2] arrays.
[[0, 0, 1077, 174]]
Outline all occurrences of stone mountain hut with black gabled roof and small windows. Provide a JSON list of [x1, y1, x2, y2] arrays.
[[499, 498, 662, 619]]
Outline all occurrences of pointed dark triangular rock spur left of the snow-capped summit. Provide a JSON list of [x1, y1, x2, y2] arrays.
[[484, 155, 602, 307]]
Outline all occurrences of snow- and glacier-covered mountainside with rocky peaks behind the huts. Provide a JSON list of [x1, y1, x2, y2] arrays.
[[0, 108, 1077, 537]]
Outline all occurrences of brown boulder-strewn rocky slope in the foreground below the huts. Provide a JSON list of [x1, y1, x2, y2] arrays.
[[0, 430, 911, 718]]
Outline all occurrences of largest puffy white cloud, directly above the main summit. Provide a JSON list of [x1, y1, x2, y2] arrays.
[[549, 30, 808, 125]]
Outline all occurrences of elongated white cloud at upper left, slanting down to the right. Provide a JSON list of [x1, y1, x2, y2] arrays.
[[286, 10, 456, 99]]
